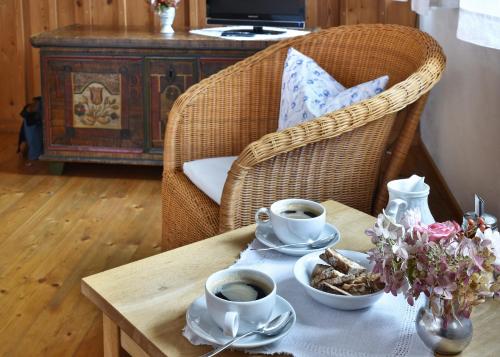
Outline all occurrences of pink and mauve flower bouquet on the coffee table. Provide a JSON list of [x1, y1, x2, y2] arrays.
[[366, 210, 500, 322]]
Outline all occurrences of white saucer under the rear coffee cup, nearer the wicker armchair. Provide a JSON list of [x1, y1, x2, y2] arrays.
[[255, 223, 340, 257]]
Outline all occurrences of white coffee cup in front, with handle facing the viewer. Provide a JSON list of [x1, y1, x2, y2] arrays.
[[205, 268, 276, 337]]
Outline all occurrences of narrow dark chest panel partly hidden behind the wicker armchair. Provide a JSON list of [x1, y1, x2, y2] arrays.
[[147, 58, 198, 151]]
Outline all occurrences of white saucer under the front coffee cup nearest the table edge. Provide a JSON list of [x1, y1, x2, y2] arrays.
[[186, 295, 297, 349]]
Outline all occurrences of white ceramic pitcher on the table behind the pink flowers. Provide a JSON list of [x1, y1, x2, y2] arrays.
[[385, 175, 436, 224]]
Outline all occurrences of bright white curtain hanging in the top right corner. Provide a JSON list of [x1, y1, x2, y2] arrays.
[[400, 0, 500, 49]]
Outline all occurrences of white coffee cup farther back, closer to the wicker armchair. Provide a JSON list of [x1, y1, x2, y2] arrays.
[[255, 198, 326, 244]]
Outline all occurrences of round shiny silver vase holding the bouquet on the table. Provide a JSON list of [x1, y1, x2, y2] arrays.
[[415, 302, 472, 355]]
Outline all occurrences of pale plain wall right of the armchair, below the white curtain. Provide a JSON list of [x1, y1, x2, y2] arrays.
[[420, 9, 500, 217]]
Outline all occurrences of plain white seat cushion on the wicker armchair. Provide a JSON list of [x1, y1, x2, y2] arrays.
[[182, 156, 237, 205]]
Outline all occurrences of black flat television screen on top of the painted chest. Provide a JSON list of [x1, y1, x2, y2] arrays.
[[207, 0, 305, 27]]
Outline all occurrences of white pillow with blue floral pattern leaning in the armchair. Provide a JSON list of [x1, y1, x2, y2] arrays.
[[278, 48, 389, 131]]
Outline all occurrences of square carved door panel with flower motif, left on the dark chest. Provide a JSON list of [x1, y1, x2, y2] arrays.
[[43, 56, 145, 154]]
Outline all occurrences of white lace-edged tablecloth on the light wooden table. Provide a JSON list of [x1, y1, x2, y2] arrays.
[[184, 240, 433, 357]]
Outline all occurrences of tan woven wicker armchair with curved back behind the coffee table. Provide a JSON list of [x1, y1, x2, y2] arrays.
[[162, 25, 445, 249]]
